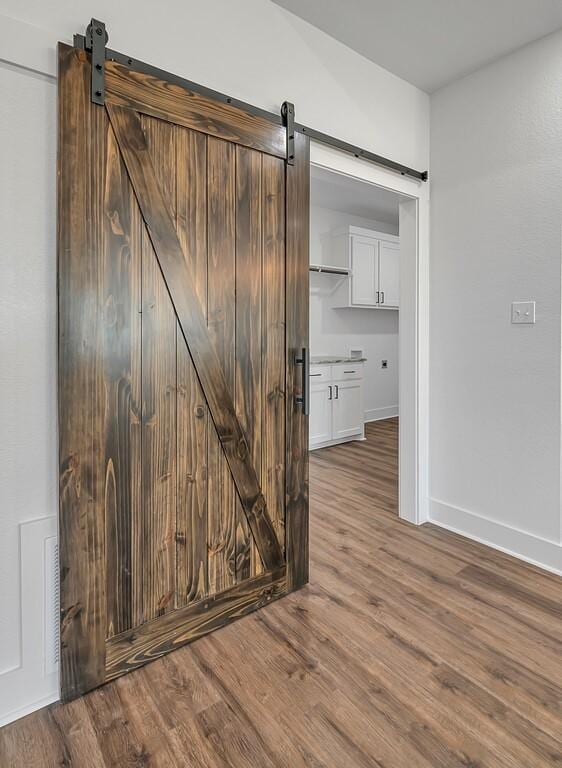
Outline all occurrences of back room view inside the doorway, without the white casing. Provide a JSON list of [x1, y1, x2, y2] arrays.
[[309, 165, 400, 515]]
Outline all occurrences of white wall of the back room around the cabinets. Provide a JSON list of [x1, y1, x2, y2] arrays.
[[310, 206, 398, 421]]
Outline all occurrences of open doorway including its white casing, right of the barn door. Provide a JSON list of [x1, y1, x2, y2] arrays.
[[309, 142, 429, 524]]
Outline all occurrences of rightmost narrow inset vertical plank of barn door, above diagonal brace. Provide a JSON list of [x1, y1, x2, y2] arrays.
[[262, 155, 282, 548]]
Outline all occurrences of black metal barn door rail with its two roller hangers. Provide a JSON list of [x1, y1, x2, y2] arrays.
[[73, 19, 429, 181]]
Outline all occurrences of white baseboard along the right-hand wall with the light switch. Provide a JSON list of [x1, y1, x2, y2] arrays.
[[429, 499, 562, 575]]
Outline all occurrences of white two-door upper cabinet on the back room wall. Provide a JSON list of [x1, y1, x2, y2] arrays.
[[332, 226, 400, 309]]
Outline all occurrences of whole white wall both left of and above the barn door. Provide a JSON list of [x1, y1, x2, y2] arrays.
[[0, 0, 429, 724]]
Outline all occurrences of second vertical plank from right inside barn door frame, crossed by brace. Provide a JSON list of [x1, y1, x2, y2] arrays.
[[235, 147, 264, 582]]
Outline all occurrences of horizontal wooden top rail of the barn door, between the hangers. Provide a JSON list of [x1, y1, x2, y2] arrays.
[[105, 61, 286, 158]]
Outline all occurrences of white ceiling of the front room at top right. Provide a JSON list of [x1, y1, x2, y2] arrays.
[[273, 0, 562, 93]]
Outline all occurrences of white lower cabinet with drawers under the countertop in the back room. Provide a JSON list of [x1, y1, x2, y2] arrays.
[[309, 363, 365, 449]]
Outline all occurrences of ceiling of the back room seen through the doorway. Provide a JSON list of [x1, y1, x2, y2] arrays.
[[310, 166, 399, 226]]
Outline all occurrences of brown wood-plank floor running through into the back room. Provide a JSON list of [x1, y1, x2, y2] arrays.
[[0, 420, 562, 768]]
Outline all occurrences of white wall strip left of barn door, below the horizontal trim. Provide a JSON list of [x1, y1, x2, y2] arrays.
[[0, 61, 58, 725]]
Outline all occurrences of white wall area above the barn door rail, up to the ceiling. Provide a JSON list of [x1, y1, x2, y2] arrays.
[[0, 0, 429, 170]]
